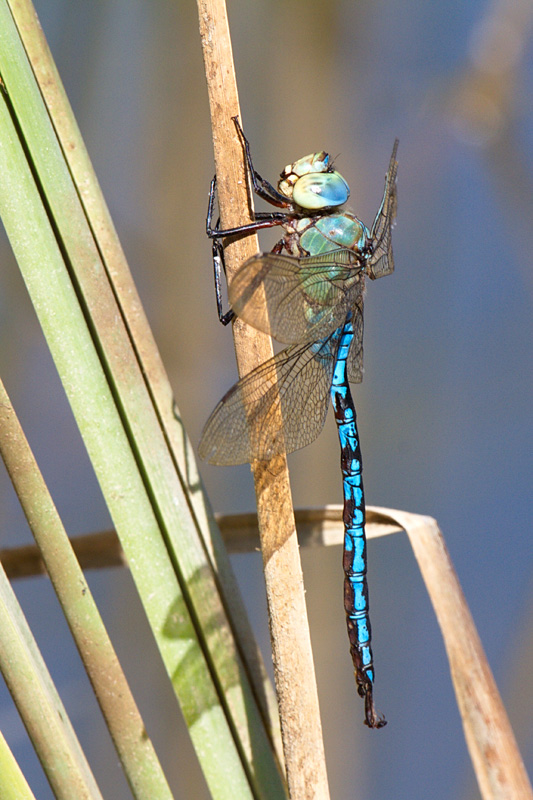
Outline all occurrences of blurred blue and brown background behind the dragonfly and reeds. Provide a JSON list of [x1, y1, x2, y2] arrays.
[[0, 0, 533, 800]]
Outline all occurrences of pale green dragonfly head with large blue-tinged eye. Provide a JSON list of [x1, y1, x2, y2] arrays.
[[278, 150, 350, 211]]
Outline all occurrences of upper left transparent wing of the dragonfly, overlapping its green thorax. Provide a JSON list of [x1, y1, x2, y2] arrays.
[[229, 250, 364, 344]]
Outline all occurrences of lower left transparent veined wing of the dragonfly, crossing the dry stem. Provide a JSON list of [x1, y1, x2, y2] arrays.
[[199, 331, 340, 465]]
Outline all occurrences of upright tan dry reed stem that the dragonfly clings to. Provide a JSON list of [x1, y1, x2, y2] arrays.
[[198, 0, 329, 800]]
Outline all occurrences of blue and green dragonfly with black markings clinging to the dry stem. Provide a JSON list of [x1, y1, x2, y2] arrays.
[[199, 117, 398, 728]]
